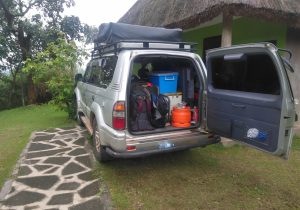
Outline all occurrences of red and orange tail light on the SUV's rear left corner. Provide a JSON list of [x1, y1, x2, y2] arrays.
[[112, 101, 126, 130]]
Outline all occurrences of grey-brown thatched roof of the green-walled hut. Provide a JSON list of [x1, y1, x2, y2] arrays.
[[119, 0, 300, 29]]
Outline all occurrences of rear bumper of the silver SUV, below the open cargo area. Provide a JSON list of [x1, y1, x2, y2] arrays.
[[105, 134, 220, 158]]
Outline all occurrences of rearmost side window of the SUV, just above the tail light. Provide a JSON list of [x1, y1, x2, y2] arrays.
[[100, 56, 118, 88]]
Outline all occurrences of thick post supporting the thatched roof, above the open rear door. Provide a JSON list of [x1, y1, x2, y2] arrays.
[[221, 11, 232, 47]]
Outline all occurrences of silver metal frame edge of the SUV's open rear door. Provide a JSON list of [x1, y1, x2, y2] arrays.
[[207, 43, 296, 159]]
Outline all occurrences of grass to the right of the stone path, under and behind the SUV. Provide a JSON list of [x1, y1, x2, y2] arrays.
[[95, 135, 300, 209]]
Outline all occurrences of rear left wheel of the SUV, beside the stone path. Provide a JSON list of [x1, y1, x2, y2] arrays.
[[93, 119, 112, 163]]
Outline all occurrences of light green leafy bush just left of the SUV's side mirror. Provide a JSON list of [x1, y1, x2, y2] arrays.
[[23, 36, 84, 117]]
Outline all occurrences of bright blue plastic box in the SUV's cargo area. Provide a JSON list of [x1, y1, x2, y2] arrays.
[[149, 72, 178, 94]]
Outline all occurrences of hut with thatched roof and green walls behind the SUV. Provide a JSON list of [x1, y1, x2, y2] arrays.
[[119, 0, 300, 126]]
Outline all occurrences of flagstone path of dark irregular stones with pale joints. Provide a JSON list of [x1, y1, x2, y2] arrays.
[[0, 127, 108, 210]]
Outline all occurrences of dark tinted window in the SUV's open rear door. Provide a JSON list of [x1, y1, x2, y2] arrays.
[[211, 54, 280, 95]]
